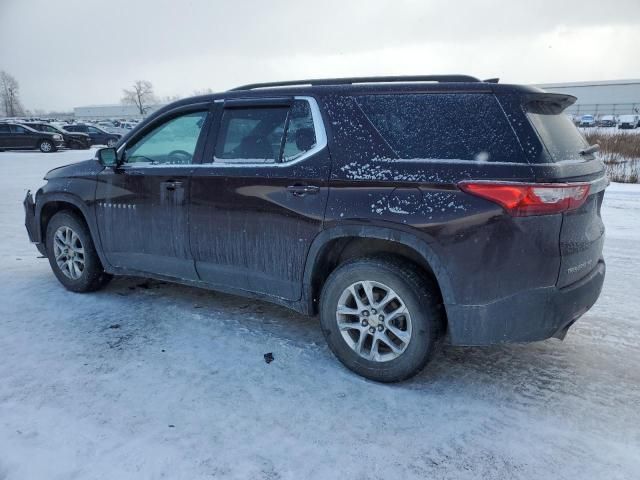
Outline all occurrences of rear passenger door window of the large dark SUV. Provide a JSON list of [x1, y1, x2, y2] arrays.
[[214, 100, 316, 163]]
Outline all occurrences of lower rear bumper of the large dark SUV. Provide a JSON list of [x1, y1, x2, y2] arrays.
[[447, 259, 606, 345]]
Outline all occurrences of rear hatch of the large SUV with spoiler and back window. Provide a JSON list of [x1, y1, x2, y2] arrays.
[[526, 94, 609, 287]]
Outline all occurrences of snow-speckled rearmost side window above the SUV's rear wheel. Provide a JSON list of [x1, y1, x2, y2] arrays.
[[356, 93, 524, 162]]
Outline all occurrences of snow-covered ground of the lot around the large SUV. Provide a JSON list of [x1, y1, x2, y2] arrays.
[[0, 148, 640, 480]]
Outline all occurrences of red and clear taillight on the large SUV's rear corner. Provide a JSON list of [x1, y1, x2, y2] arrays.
[[458, 181, 589, 217]]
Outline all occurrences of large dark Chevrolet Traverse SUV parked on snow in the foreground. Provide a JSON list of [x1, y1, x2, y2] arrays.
[[24, 76, 608, 382]]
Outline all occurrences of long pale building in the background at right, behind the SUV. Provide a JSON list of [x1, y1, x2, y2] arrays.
[[535, 79, 640, 116]]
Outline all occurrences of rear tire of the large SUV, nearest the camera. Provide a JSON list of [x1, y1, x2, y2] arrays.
[[320, 256, 444, 382]]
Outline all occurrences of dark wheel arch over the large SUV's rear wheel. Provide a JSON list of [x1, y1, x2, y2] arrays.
[[302, 225, 455, 314]]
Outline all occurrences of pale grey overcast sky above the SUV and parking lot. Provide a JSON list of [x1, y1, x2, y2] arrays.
[[0, 0, 640, 110]]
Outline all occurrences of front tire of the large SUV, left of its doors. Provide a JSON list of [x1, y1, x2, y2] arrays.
[[46, 210, 112, 293]]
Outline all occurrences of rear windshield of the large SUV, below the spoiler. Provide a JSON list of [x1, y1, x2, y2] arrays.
[[527, 111, 589, 162]]
